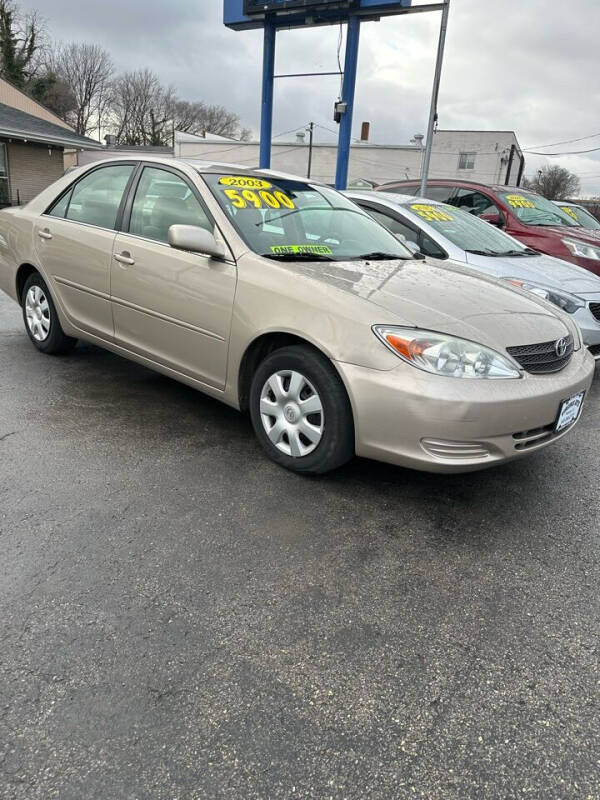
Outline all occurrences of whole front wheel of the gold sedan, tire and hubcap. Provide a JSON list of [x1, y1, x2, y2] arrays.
[[250, 345, 354, 475]]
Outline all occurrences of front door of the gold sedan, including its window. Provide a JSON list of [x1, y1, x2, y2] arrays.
[[111, 166, 237, 389]]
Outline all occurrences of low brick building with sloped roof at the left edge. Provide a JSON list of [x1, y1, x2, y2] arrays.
[[0, 78, 102, 206]]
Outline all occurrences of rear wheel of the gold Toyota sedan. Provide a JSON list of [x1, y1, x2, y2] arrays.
[[21, 272, 77, 355]]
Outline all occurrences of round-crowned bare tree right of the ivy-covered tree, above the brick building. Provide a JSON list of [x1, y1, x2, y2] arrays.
[[46, 42, 114, 136]]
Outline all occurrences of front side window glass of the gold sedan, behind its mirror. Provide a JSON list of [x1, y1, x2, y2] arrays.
[[129, 167, 214, 242]]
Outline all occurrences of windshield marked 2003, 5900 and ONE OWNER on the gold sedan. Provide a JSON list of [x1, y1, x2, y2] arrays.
[[202, 173, 413, 261]]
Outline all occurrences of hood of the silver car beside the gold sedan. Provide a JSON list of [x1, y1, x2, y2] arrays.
[[466, 253, 600, 297]]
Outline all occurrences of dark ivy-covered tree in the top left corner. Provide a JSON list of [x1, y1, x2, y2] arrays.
[[0, 0, 45, 89]]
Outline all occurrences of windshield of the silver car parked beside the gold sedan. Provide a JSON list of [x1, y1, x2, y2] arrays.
[[402, 200, 527, 255]]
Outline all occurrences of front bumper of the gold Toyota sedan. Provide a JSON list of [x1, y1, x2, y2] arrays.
[[337, 348, 595, 472]]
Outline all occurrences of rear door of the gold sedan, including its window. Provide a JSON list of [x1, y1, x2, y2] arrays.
[[34, 163, 137, 340]]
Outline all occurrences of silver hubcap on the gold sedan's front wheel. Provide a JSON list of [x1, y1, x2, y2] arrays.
[[260, 370, 325, 458]]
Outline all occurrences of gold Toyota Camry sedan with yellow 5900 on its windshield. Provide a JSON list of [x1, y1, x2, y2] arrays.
[[0, 158, 594, 473]]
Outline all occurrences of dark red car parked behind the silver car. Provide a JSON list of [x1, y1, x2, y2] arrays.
[[376, 180, 600, 275]]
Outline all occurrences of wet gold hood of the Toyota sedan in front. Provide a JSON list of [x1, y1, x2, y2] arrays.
[[282, 259, 571, 349]]
